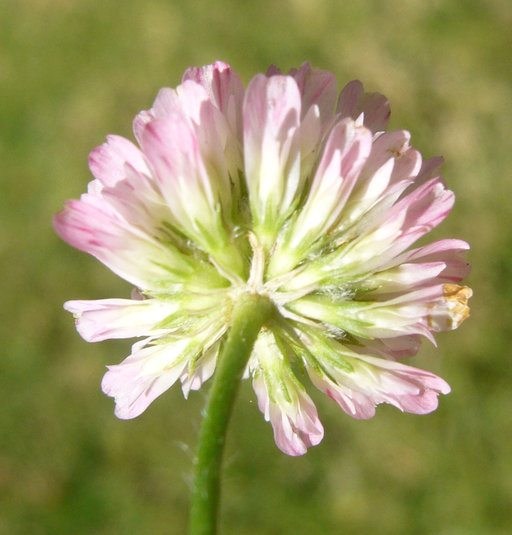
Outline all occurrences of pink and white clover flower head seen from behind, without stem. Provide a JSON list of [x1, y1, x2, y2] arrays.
[[54, 62, 471, 455]]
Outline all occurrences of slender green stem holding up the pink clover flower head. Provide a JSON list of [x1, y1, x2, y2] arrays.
[[190, 294, 274, 535]]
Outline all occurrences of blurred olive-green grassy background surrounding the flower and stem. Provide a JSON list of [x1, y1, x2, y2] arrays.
[[0, 0, 512, 535]]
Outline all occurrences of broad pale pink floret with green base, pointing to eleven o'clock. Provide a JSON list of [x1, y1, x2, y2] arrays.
[[142, 99, 245, 274]]
